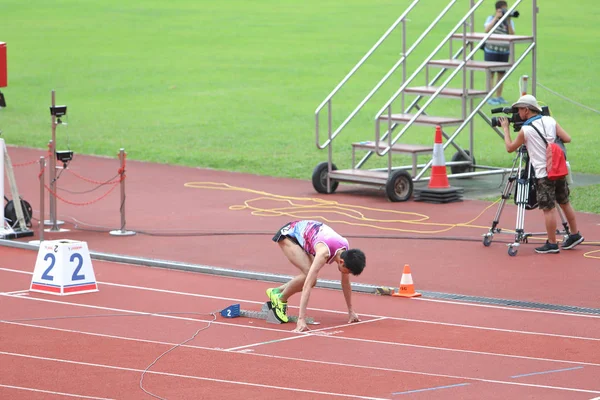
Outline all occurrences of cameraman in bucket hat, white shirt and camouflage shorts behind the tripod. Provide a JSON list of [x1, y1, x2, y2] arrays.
[[498, 95, 584, 253]]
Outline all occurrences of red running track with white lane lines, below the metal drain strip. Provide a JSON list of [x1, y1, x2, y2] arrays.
[[0, 248, 600, 400]]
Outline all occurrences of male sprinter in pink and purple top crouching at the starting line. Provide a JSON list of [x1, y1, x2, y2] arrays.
[[267, 220, 366, 332]]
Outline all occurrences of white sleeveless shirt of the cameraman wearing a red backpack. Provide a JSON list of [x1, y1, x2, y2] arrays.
[[521, 116, 556, 179]]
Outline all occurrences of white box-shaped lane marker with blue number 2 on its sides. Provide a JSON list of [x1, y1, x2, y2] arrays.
[[29, 240, 98, 296]]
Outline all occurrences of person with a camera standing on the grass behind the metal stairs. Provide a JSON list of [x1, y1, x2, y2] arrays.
[[483, 1, 515, 106]]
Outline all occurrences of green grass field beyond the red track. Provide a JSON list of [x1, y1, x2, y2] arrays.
[[0, 0, 600, 212]]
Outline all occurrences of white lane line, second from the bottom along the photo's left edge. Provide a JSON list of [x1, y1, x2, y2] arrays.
[[0, 351, 390, 400]]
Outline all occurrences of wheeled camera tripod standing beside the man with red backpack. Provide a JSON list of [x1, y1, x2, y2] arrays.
[[483, 145, 570, 256]]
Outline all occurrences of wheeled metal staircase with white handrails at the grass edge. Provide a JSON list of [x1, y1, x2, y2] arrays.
[[312, 0, 537, 201]]
